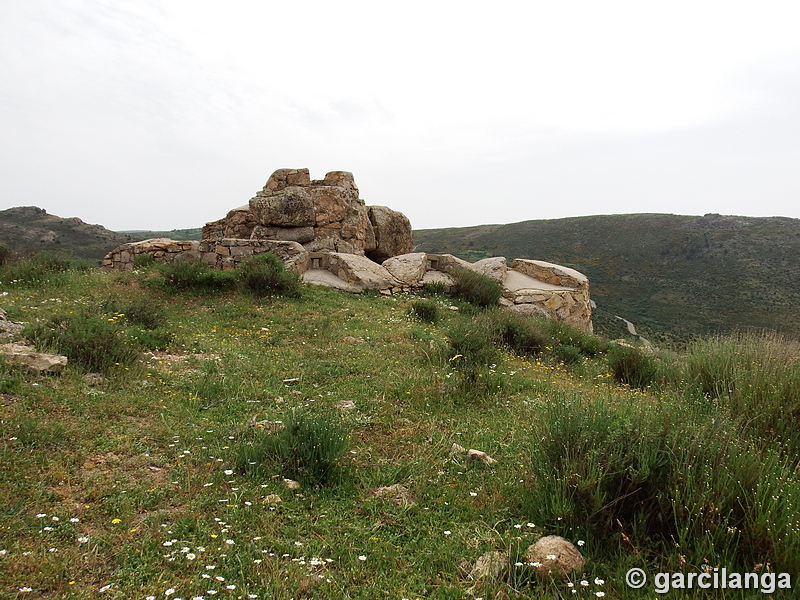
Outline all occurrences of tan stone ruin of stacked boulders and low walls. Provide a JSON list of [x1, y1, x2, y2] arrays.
[[103, 169, 592, 332]]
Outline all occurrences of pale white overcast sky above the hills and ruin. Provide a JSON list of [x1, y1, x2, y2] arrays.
[[0, 0, 800, 230]]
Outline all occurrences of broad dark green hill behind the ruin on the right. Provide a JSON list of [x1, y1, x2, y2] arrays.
[[414, 214, 800, 341]]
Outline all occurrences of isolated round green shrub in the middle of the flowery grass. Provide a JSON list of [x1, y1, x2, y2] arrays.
[[237, 409, 349, 485]]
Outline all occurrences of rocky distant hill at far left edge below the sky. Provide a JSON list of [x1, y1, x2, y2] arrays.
[[0, 206, 132, 262]]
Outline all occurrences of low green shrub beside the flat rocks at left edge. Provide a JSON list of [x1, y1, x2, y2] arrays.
[[24, 313, 139, 373]]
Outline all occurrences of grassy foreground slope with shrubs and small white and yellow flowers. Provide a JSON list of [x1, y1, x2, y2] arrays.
[[0, 258, 800, 600]]
